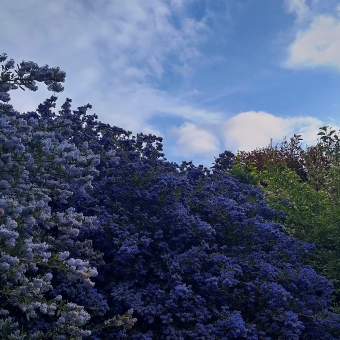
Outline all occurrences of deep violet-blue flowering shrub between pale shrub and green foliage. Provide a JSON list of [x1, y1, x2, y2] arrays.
[[37, 99, 340, 339]]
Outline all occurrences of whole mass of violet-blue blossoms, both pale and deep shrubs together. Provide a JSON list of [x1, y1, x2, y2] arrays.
[[0, 51, 340, 340]]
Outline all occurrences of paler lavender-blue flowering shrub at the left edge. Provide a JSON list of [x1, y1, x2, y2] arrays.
[[0, 53, 134, 340]]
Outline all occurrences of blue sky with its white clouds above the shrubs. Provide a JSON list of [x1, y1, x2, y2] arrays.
[[0, 0, 340, 168]]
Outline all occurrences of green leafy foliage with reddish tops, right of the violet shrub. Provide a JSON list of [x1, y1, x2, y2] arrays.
[[219, 126, 340, 311]]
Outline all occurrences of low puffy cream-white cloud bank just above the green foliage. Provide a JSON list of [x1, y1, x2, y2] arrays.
[[165, 111, 334, 166]]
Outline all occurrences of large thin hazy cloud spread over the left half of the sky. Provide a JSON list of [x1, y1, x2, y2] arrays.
[[0, 0, 214, 135]]
